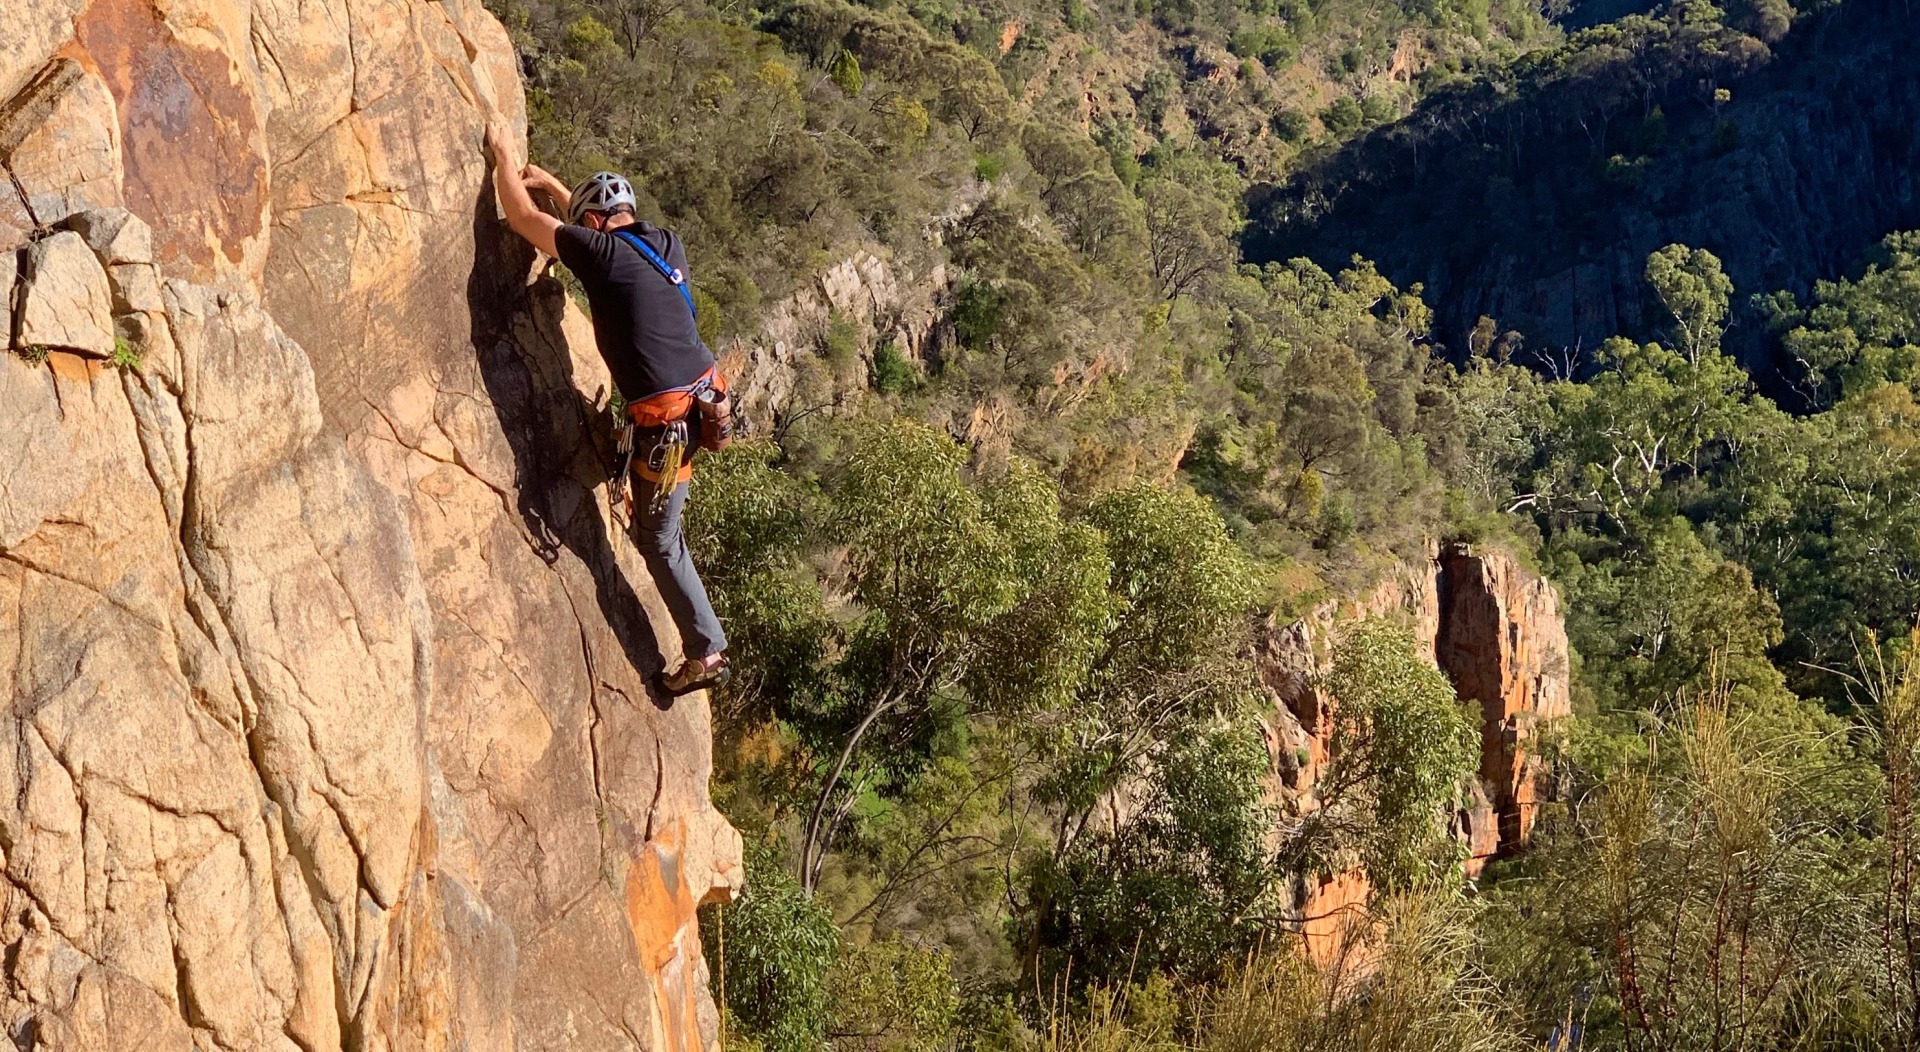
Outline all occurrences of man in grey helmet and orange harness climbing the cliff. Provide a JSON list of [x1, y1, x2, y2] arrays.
[[486, 117, 730, 695]]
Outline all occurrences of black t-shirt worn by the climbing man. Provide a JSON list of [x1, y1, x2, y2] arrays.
[[553, 223, 714, 401]]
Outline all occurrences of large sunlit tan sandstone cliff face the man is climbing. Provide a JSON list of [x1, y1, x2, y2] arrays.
[[0, 0, 741, 1052]]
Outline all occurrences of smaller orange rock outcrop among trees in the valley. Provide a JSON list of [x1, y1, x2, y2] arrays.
[[1256, 545, 1571, 962]]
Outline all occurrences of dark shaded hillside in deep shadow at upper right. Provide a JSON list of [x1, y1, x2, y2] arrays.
[[1246, 0, 1920, 389]]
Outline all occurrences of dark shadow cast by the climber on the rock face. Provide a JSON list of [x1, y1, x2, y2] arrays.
[[467, 170, 672, 698]]
